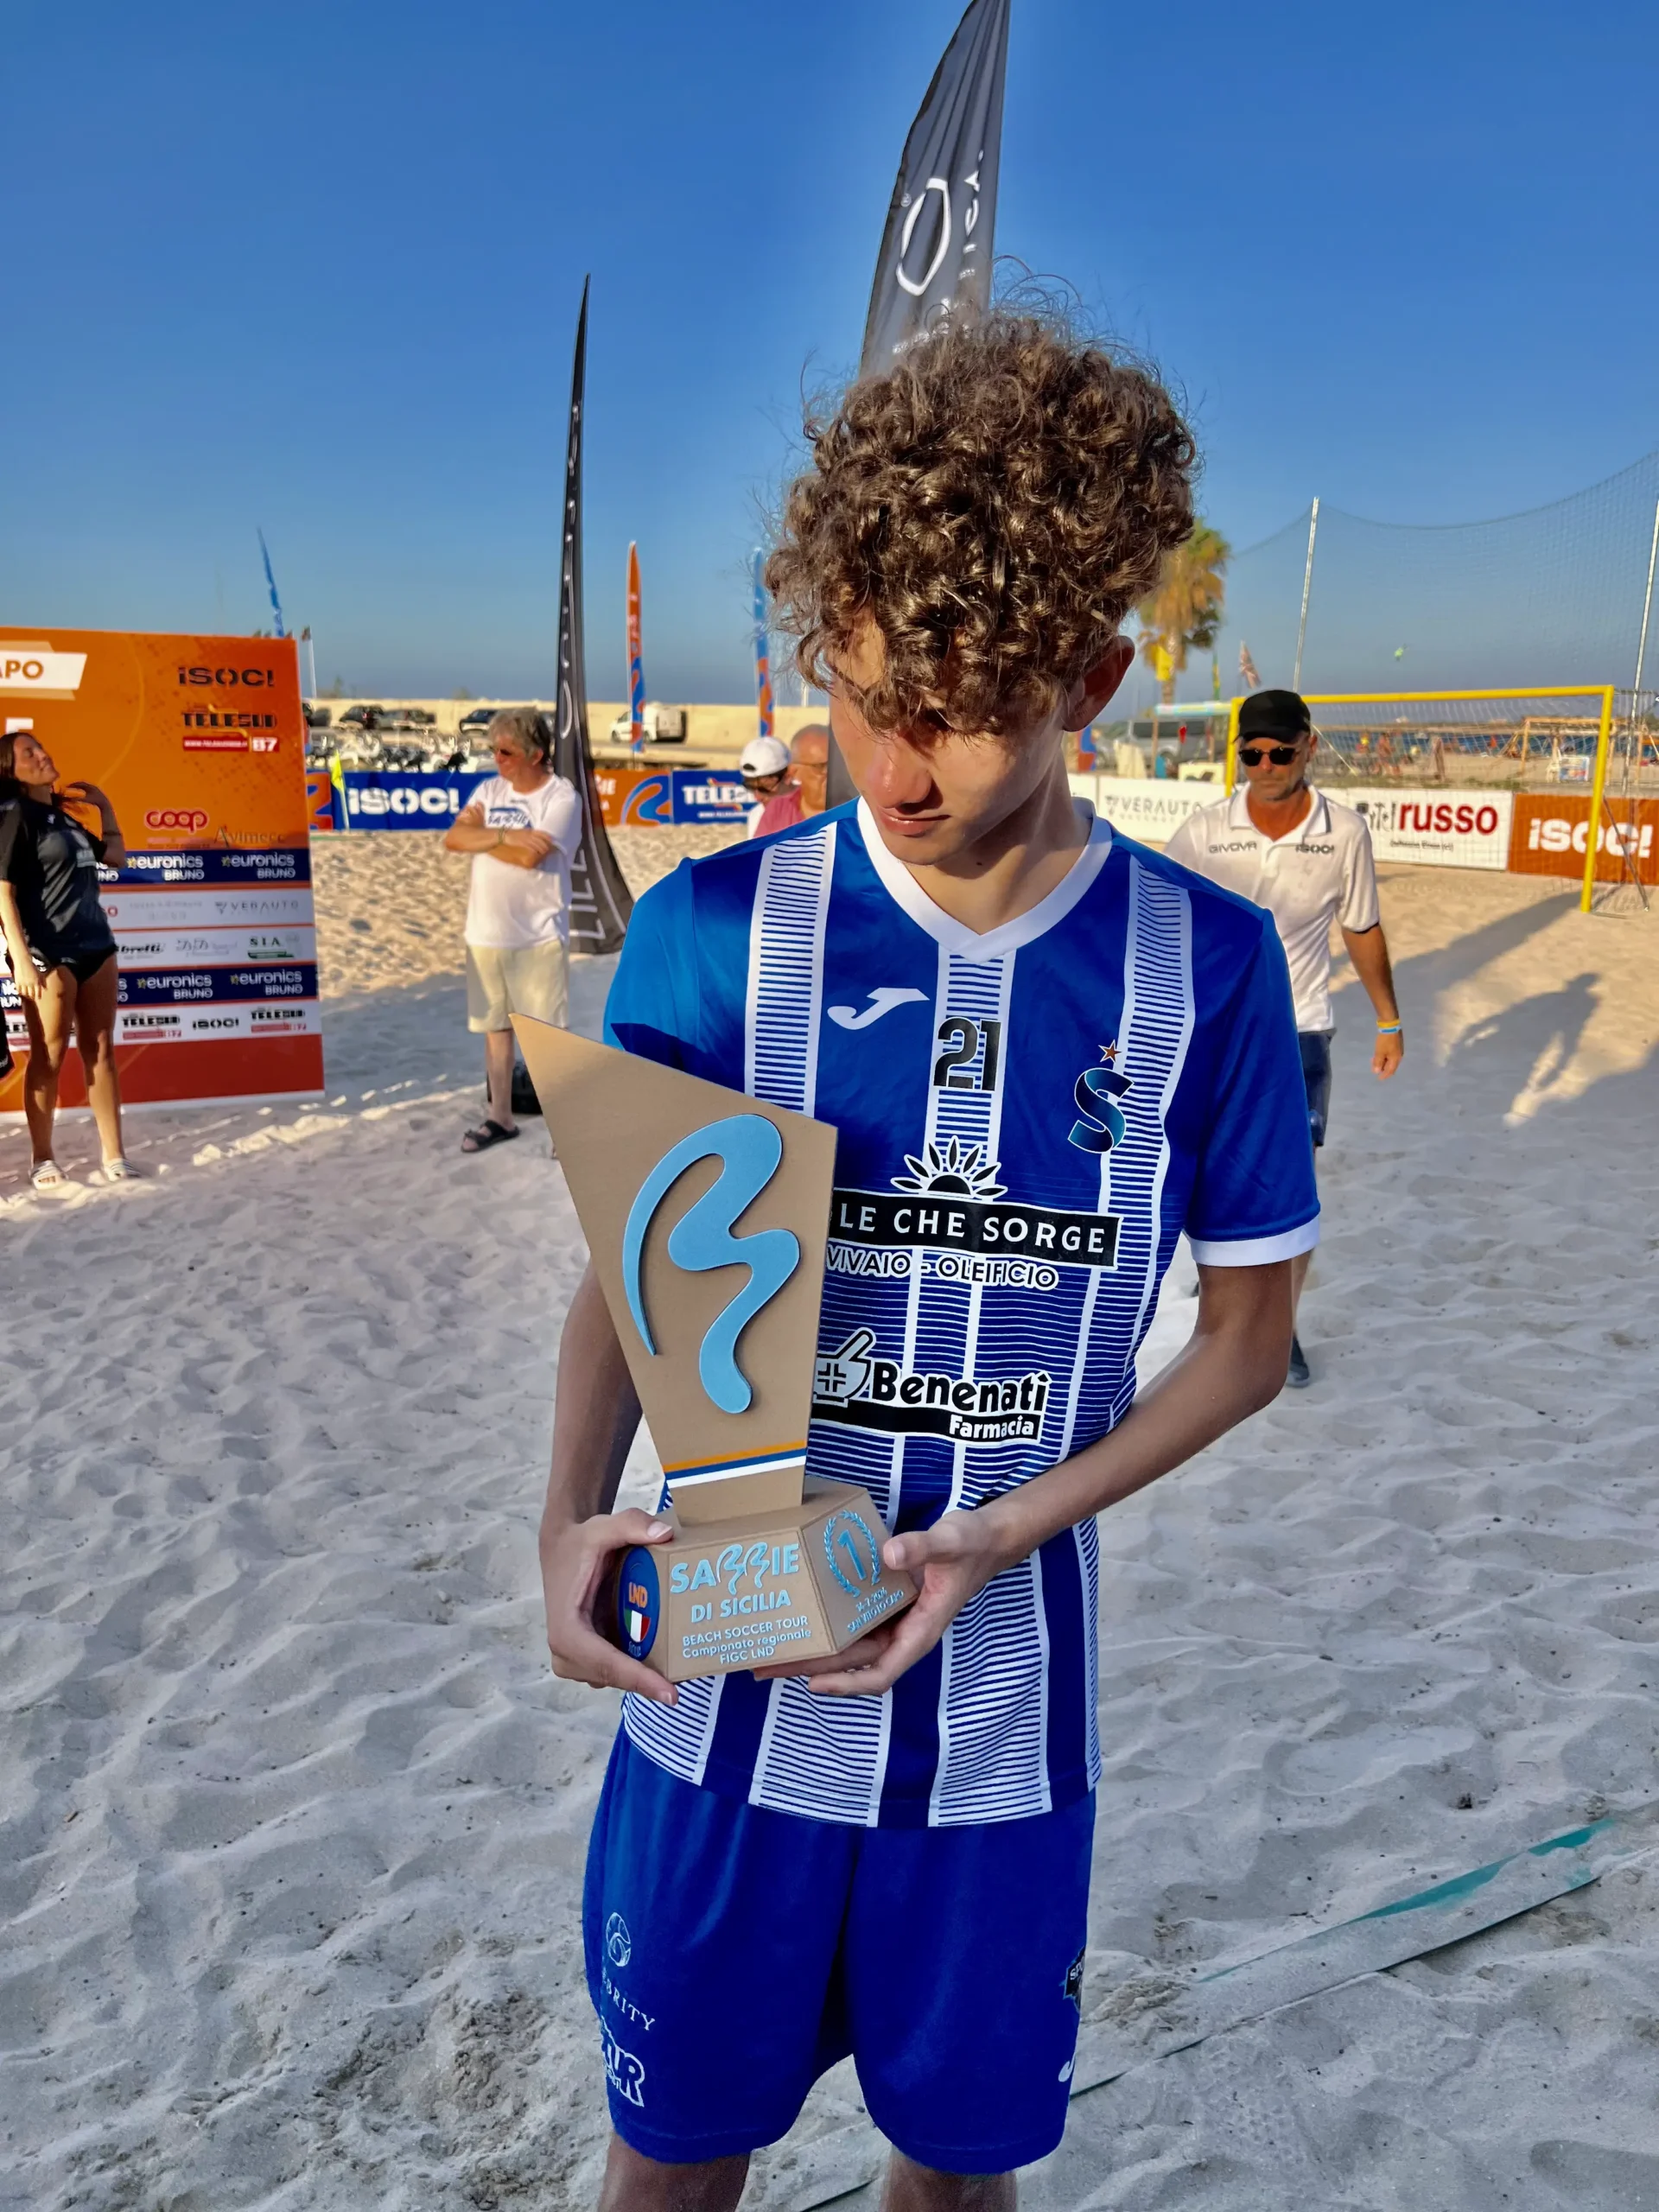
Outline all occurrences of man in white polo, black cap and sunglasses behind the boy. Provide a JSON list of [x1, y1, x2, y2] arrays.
[[1166, 690, 1405, 1389]]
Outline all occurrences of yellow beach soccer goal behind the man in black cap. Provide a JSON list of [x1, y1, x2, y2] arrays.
[[1225, 683, 1637, 913]]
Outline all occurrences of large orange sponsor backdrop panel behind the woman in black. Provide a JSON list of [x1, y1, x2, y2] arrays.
[[0, 626, 323, 1113]]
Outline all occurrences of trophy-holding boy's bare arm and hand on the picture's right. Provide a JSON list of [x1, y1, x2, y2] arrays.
[[754, 1259, 1292, 1697]]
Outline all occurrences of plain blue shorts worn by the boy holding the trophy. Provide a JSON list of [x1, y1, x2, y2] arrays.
[[582, 1734, 1095, 2174]]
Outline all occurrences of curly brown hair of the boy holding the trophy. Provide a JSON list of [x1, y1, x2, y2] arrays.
[[766, 312, 1197, 734]]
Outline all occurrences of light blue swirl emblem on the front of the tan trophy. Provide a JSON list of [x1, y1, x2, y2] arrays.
[[621, 1113, 801, 1414]]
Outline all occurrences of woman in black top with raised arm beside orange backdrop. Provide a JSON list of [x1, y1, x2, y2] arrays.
[[0, 730, 137, 1190]]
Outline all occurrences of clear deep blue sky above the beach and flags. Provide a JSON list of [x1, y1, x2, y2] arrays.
[[0, 0, 1659, 699]]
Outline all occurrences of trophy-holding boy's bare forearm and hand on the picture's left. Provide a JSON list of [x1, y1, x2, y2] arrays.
[[540, 1265, 675, 1706]]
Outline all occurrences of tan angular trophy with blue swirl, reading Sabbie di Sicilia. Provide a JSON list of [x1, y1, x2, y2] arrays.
[[513, 1015, 916, 1681]]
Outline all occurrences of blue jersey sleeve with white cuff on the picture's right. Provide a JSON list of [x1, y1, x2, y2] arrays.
[[1185, 913, 1319, 1268]]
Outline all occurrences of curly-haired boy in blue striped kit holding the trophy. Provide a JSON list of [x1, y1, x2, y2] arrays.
[[542, 316, 1319, 2212]]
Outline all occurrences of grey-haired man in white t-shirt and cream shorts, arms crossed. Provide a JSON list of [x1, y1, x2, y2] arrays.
[[445, 706, 582, 1153]]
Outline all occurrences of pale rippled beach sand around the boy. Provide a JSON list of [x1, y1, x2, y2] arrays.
[[0, 832, 1659, 2212]]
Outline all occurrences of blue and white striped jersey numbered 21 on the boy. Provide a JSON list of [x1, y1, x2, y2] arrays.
[[606, 807, 1319, 1827]]
